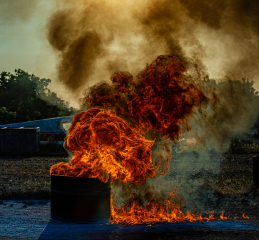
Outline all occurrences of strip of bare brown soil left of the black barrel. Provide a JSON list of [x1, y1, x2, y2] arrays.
[[0, 157, 68, 199]]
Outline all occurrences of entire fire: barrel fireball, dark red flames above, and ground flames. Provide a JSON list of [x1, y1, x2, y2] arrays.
[[50, 55, 252, 224]]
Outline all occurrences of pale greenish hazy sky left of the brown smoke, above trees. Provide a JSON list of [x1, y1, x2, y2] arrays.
[[0, 0, 76, 105]]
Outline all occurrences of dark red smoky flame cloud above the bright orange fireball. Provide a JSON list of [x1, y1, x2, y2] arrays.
[[84, 55, 208, 139]]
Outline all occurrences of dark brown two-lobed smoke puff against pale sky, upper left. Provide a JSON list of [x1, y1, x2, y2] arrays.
[[48, 5, 103, 92]]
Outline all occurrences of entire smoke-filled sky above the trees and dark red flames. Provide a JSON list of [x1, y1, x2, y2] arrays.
[[0, 0, 259, 106]]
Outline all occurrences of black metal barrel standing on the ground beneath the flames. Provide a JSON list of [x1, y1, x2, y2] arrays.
[[51, 175, 110, 223]]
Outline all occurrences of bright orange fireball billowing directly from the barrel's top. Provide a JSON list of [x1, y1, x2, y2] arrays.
[[50, 108, 156, 184]]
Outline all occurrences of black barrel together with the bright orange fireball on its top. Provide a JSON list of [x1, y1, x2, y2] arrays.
[[50, 108, 156, 222]]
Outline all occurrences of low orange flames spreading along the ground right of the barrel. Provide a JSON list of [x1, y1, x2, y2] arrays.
[[109, 191, 249, 225]]
